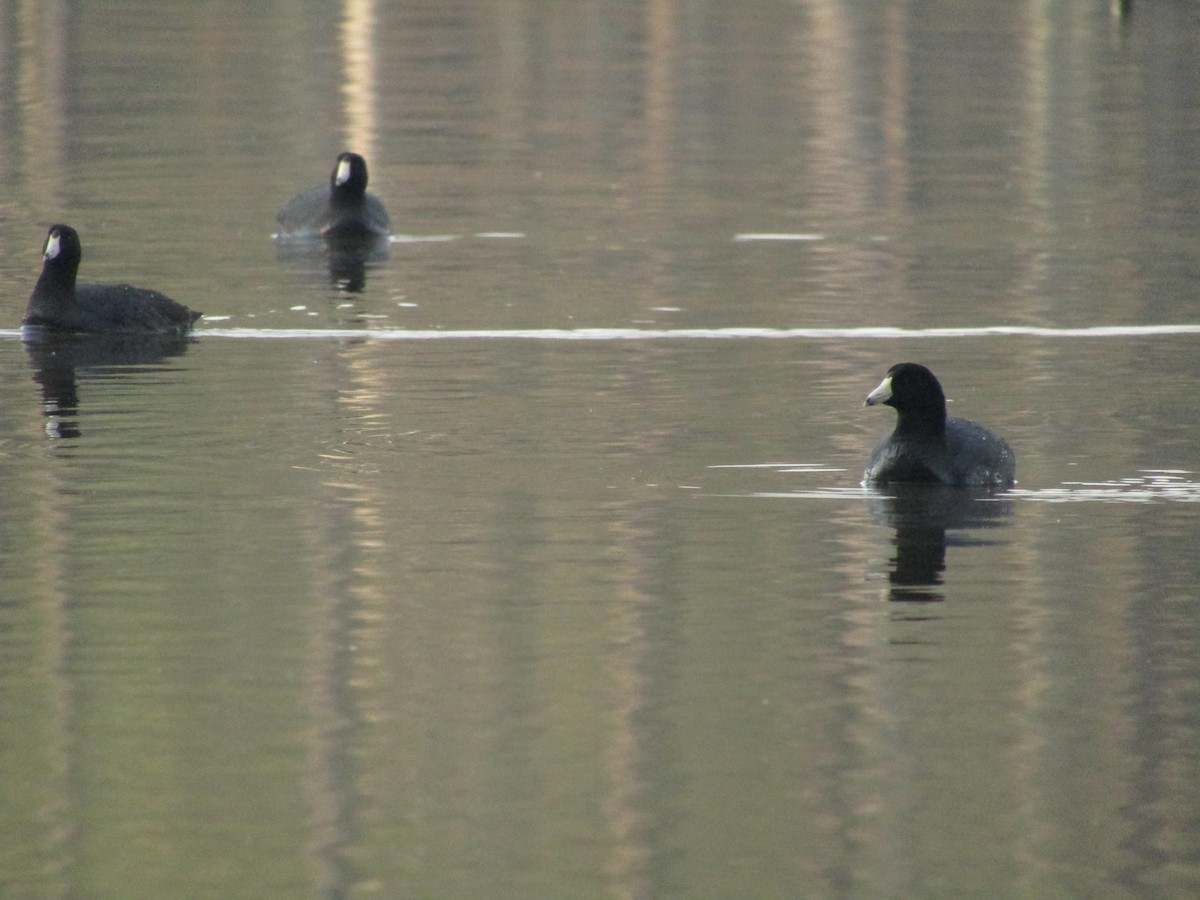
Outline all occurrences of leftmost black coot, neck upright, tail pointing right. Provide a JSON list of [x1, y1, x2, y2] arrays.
[[22, 224, 200, 335]]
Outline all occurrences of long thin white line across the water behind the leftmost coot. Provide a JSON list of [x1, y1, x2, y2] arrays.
[[0, 316, 1200, 341]]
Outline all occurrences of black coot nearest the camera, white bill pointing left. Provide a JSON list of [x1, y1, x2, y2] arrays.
[[863, 362, 1016, 487]]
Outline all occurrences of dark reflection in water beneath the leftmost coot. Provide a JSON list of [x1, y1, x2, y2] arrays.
[[23, 329, 196, 438]]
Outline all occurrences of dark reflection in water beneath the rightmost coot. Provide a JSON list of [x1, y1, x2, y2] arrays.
[[868, 485, 1013, 602]]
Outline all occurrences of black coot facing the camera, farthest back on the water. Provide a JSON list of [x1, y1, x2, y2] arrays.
[[278, 152, 391, 241]]
